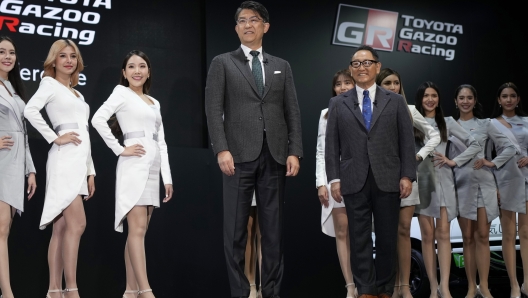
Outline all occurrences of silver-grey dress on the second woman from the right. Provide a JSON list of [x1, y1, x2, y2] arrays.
[[449, 118, 515, 222]]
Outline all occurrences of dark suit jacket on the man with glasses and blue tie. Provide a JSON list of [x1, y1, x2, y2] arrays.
[[325, 86, 416, 195]]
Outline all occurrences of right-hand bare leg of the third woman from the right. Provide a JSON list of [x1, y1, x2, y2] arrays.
[[435, 207, 451, 298]]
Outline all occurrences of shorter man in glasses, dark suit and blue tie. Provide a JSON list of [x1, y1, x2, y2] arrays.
[[325, 46, 416, 298]]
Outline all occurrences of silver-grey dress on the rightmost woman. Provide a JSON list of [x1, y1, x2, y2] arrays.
[[493, 115, 528, 214]]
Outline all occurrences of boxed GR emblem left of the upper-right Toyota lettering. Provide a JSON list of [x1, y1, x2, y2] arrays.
[[332, 4, 398, 52]]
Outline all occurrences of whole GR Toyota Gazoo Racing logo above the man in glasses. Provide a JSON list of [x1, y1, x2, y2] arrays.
[[332, 4, 463, 61]]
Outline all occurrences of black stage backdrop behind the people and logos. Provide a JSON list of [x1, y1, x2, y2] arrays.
[[1, 0, 528, 297]]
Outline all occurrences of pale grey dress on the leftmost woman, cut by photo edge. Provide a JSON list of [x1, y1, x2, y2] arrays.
[[0, 78, 36, 212]]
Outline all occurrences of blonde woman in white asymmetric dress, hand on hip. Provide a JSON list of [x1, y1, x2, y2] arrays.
[[24, 39, 95, 298]]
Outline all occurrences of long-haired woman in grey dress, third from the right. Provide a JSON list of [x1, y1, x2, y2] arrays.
[[415, 82, 480, 298]]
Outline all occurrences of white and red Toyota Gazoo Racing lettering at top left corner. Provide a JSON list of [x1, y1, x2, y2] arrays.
[[0, 0, 112, 45]]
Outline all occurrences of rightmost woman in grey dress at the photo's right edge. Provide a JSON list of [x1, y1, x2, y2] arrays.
[[486, 83, 528, 297]]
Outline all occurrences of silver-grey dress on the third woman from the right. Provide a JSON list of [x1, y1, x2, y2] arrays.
[[415, 117, 480, 221]]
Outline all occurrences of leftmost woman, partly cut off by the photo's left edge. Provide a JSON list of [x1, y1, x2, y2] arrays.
[[0, 36, 37, 298]]
